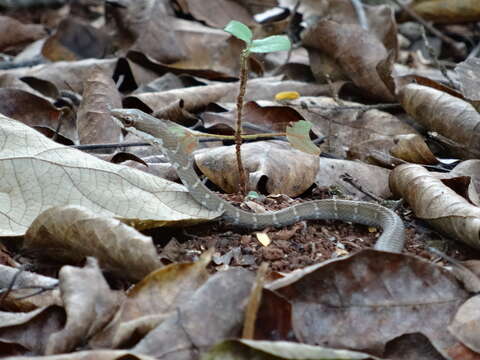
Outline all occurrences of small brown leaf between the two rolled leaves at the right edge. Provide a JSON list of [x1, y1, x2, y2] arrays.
[[390, 134, 439, 165]]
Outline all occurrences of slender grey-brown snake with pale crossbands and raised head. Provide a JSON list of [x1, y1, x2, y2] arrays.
[[110, 109, 405, 253]]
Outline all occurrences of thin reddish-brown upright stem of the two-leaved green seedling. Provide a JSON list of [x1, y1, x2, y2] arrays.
[[235, 49, 249, 195]]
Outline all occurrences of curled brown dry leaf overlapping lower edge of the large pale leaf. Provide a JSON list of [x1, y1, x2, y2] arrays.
[[23, 205, 161, 281]]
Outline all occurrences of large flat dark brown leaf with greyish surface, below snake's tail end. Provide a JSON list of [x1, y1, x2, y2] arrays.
[[267, 250, 468, 356]]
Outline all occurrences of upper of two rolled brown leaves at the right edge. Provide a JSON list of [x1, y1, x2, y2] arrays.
[[399, 84, 480, 158]]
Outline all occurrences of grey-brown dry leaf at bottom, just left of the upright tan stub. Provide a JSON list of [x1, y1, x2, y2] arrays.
[[132, 268, 254, 360]]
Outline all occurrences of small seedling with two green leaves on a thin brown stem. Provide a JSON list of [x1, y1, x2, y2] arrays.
[[224, 20, 292, 195]]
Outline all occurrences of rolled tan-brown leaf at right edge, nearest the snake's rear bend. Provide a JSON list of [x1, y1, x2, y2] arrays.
[[390, 164, 480, 249]]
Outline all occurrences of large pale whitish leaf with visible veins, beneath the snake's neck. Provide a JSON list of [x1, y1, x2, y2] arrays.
[[0, 116, 219, 236]]
